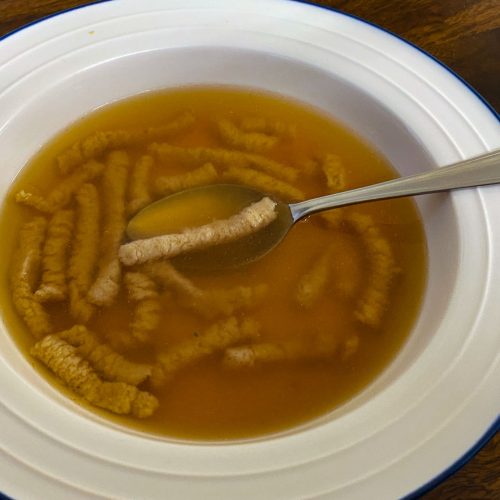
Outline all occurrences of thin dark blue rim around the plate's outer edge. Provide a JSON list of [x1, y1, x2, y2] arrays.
[[0, 0, 500, 500]]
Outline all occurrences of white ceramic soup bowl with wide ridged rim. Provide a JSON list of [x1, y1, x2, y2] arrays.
[[0, 0, 500, 499]]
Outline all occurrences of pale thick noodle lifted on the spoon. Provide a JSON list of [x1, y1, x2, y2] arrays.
[[119, 197, 277, 266]]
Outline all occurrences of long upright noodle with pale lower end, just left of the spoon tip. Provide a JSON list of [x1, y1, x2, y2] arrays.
[[87, 151, 130, 306]]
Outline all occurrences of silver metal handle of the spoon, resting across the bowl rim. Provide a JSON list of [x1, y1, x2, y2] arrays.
[[290, 149, 500, 222]]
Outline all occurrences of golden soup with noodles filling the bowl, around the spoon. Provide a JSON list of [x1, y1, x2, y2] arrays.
[[0, 87, 426, 440]]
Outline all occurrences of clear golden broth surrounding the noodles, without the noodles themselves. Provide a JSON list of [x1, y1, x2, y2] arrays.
[[0, 87, 426, 440]]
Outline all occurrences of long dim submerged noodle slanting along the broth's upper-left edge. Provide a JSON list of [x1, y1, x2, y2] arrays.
[[56, 111, 195, 174]]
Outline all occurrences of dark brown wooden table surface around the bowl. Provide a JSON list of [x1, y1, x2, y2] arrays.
[[0, 0, 500, 500]]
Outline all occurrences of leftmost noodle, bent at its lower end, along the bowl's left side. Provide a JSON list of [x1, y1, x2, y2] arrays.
[[11, 217, 52, 338]]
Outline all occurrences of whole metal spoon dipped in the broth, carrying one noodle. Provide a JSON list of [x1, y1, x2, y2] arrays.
[[127, 150, 500, 269]]
